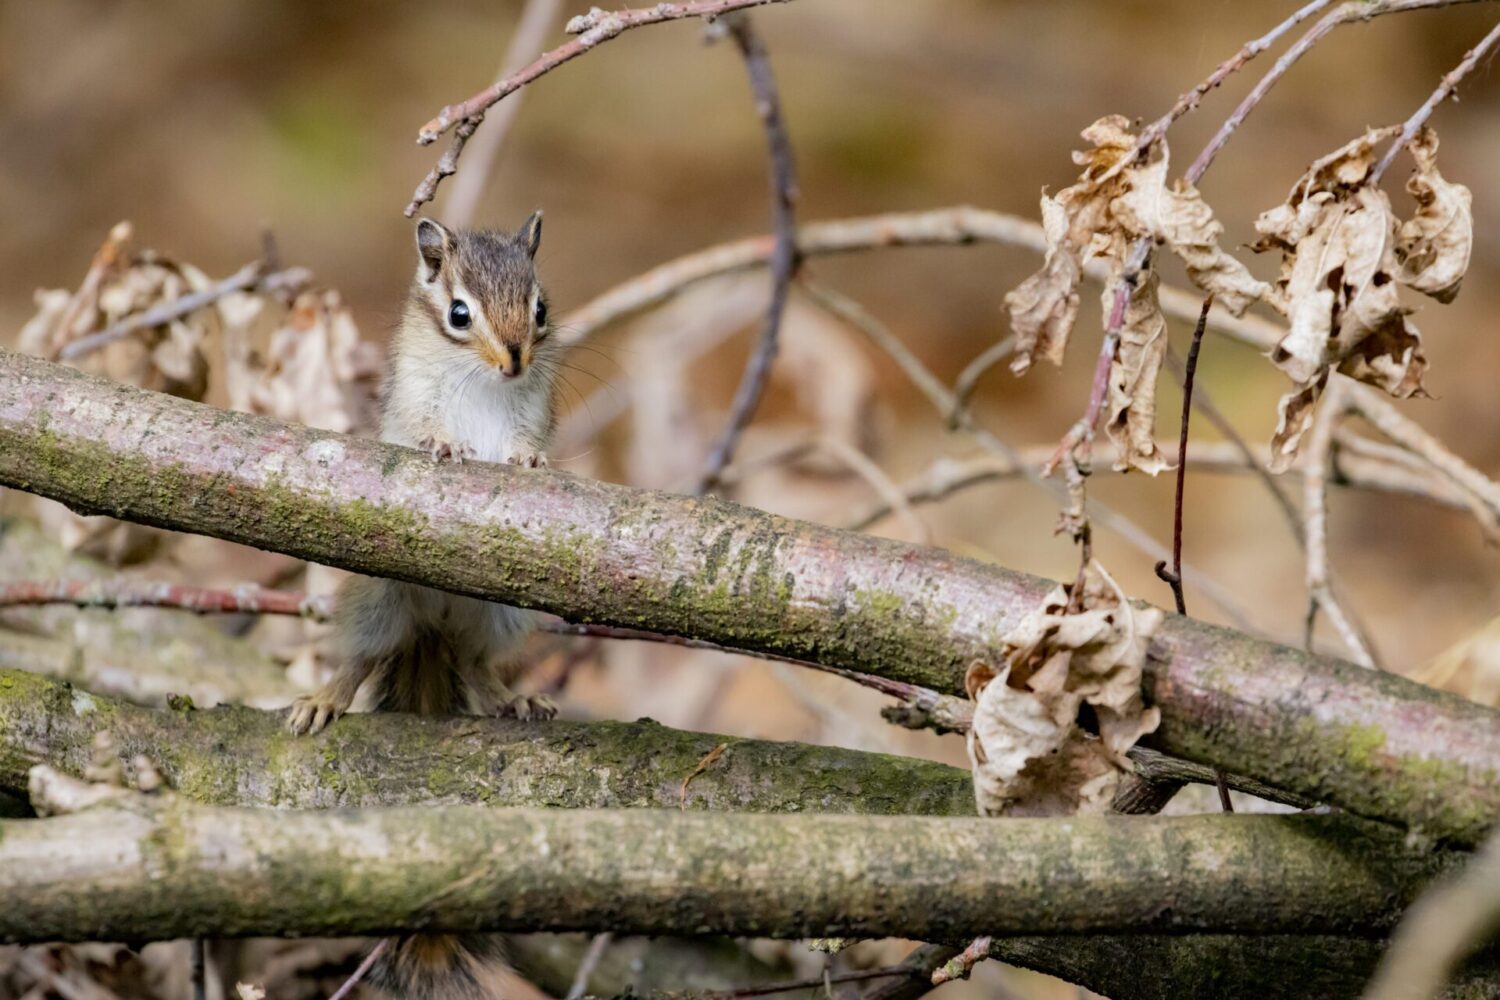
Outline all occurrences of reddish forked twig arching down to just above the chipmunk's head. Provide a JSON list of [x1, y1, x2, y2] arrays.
[[405, 0, 791, 217]]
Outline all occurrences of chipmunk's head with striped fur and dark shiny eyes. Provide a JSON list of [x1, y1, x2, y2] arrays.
[[411, 211, 549, 378]]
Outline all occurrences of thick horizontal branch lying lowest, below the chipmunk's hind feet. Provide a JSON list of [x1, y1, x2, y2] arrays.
[[0, 768, 1457, 942]]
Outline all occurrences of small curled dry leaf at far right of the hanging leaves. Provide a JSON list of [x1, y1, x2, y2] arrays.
[[1395, 127, 1475, 303]]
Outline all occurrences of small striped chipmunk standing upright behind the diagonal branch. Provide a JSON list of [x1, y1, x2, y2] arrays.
[[287, 211, 561, 1000]]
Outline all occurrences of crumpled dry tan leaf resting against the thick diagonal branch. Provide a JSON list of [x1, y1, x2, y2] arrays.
[[966, 565, 1163, 816]]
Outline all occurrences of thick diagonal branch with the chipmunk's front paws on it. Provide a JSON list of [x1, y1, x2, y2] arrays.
[[0, 354, 1500, 844]]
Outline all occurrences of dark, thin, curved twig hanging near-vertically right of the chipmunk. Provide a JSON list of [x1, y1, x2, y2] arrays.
[[696, 17, 801, 493]]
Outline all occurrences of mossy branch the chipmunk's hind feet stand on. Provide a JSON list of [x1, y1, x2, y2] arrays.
[[0, 670, 974, 816]]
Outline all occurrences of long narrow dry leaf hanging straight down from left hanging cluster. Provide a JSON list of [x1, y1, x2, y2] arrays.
[[1104, 271, 1172, 475]]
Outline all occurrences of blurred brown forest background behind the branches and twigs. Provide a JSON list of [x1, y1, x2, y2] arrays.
[[0, 0, 1500, 996]]
